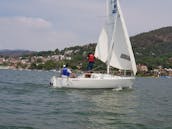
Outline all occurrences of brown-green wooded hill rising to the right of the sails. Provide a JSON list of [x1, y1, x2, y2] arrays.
[[131, 27, 172, 68]]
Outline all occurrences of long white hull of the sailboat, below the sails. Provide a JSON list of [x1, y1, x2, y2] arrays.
[[50, 75, 135, 89]]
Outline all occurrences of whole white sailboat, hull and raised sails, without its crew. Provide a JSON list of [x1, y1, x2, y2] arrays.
[[50, 0, 137, 89]]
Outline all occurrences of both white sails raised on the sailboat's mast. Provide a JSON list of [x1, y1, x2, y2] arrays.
[[95, 0, 137, 75]]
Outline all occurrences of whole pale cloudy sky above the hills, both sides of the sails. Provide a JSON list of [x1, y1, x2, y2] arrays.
[[0, 0, 172, 51]]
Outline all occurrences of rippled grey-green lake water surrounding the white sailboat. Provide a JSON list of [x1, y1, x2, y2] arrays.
[[0, 70, 172, 129]]
